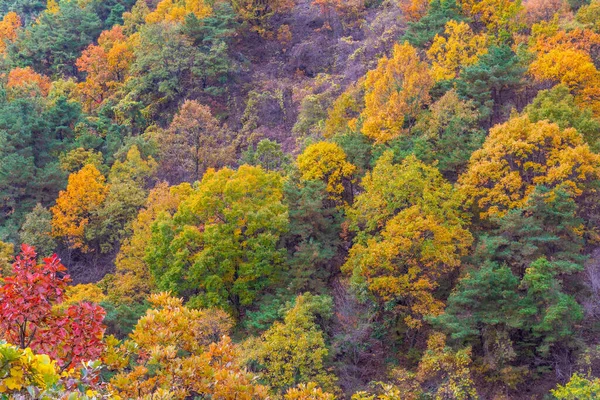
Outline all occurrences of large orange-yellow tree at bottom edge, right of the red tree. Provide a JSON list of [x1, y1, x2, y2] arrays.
[[110, 293, 267, 400]]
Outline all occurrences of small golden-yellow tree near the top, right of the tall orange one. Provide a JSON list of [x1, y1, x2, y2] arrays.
[[427, 21, 487, 81]]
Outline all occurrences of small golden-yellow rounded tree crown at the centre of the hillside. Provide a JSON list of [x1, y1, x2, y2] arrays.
[[298, 142, 356, 202]]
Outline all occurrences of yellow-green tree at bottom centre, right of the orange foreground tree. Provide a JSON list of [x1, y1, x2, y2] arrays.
[[244, 293, 335, 393]]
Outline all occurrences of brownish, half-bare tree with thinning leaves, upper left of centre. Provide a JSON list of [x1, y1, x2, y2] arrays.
[[158, 100, 235, 184]]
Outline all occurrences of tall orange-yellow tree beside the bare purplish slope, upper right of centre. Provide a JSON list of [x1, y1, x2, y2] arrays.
[[362, 43, 433, 143]]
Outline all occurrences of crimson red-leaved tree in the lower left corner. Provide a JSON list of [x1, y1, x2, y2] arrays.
[[0, 245, 104, 370]]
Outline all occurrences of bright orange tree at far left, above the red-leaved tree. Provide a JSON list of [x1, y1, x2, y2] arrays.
[[50, 164, 109, 251]]
